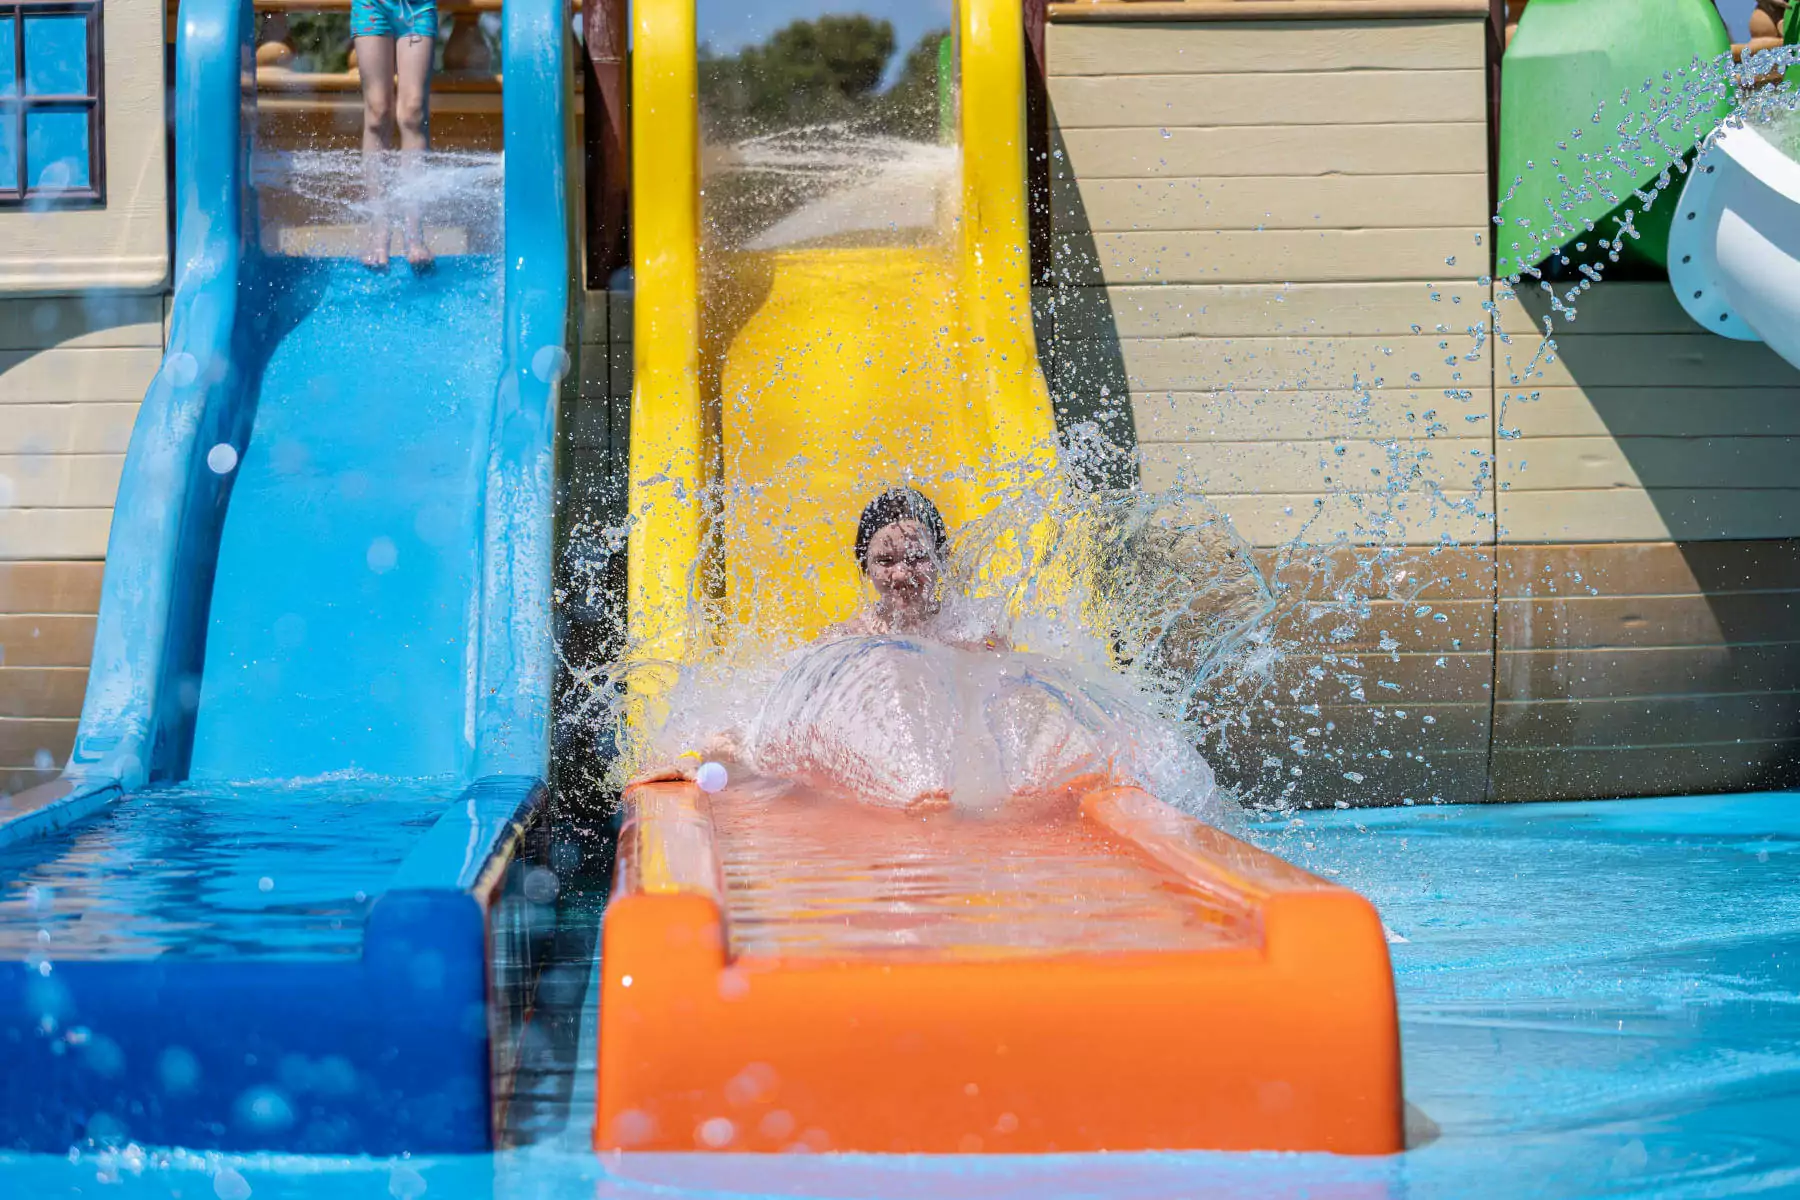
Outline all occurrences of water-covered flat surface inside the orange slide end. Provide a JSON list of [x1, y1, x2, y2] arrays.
[[713, 784, 1255, 959]]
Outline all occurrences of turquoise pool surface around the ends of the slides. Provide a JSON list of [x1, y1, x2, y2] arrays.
[[0, 793, 1800, 1200]]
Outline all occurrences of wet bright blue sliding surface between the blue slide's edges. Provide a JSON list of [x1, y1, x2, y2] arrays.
[[193, 257, 500, 779]]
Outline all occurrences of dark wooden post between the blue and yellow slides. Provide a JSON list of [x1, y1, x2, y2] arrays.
[[581, 0, 632, 290]]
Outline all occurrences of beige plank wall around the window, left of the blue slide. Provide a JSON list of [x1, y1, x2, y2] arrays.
[[0, 4, 169, 793]]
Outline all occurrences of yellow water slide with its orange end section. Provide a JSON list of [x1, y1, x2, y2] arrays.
[[594, 0, 1402, 1153]]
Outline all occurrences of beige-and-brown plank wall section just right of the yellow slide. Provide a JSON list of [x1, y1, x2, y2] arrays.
[[1040, 5, 1494, 804]]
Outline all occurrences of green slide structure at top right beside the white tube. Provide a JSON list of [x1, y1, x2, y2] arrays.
[[1496, 0, 1732, 277]]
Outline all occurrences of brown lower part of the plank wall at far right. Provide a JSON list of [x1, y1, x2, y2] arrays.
[[1494, 540, 1800, 801]]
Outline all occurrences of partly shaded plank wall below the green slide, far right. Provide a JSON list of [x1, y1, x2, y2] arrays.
[[1492, 282, 1800, 799]]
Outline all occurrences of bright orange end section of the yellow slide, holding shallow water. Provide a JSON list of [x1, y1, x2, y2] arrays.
[[594, 783, 1402, 1153]]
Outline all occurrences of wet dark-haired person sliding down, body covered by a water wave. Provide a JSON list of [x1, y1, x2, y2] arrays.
[[634, 489, 1226, 820]]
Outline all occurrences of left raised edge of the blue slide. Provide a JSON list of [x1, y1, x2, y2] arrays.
[[0, 0, 256, 846]]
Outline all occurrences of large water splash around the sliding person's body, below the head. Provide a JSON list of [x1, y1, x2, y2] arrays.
[[569, 437, 1273, 831]]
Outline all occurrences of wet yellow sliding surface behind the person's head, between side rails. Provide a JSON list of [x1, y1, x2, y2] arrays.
[[709, 246, 986, 637]]
